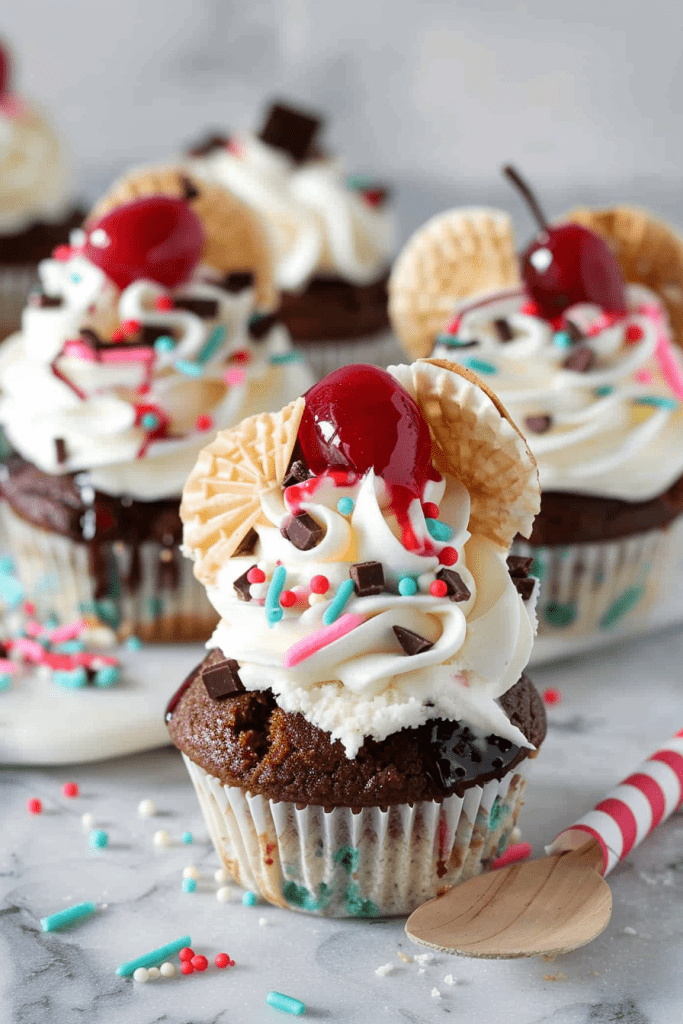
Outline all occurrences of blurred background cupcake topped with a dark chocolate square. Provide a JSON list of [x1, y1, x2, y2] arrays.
[[188, 103, 400, 376]]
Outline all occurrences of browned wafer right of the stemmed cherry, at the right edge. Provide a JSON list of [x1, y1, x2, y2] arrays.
[[562, 206, 683, 347]]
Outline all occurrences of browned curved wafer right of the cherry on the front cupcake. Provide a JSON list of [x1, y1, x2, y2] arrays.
[[390, 359, 541, 549]]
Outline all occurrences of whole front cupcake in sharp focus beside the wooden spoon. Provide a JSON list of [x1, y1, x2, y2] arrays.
[[167, 360, 545, 916]]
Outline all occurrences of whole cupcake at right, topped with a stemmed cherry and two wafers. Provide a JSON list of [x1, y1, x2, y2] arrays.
[[390, 175, 683, 659]]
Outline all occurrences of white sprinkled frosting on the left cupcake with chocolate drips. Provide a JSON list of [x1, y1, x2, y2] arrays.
[[0, 249, 312, 501]]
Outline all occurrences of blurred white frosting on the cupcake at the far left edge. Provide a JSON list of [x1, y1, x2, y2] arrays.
[[0, 96, 71, 234]]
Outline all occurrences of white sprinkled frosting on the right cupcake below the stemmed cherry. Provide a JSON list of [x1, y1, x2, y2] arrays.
[[432, 286, 683, 502]]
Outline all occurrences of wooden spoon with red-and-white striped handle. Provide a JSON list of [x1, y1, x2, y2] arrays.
[[405, 730, 683, 959]]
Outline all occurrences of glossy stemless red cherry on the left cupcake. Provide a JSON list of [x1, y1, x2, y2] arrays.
[[83, 196, 204, 289]]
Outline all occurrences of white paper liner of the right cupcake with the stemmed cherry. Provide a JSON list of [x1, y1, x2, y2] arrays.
[[512, 516, 683, 665]]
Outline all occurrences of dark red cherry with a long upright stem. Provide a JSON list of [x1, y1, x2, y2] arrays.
[[503, 167, 627, 321]]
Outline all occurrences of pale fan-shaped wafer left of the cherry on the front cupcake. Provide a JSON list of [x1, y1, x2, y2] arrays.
[[180, 398, 305, 586]]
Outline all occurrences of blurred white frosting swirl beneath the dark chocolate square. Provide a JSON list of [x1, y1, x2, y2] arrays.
[[189, 134, 395, 291]]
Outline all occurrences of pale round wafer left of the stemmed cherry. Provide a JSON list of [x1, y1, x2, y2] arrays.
[[389, 208, 519, 358]]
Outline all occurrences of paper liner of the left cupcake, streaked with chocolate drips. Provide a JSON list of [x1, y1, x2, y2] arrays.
[[0, 502, 216, 642]]
